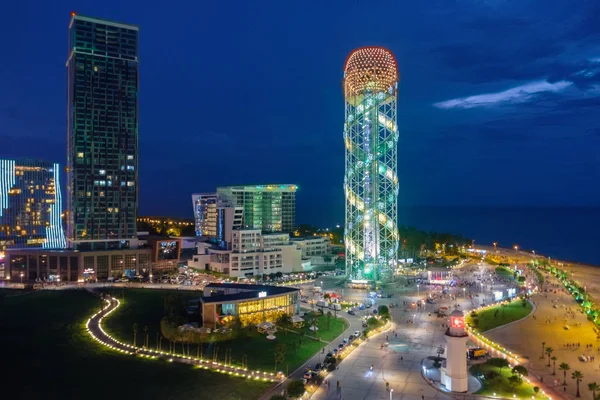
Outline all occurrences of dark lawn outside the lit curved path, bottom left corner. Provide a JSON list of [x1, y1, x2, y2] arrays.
[[0, 290, 269, 400]]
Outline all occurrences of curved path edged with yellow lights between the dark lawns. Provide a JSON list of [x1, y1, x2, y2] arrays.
[[86, 291, 279, 382]]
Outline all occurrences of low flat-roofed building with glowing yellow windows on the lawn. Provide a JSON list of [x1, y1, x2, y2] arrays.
[[200, 283, 300, 329]]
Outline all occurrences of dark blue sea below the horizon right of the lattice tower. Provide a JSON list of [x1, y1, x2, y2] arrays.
[[398, 207, 600, 267]]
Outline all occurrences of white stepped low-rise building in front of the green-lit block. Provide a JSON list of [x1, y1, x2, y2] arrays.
[[188, 229, 310, 278]]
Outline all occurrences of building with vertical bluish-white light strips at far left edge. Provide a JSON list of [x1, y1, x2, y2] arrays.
[[0, 160, 66, 250]]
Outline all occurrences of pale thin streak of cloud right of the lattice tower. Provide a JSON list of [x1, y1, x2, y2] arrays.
[[434, 81, 572, 109]]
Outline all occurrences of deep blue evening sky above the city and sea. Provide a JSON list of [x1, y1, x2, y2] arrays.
[[0, 0, 600, 223]]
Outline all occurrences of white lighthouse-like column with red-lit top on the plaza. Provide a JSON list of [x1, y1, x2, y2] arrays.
[[441, 310, 469, 393]]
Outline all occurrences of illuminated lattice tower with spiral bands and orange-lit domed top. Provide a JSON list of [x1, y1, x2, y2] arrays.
[[343, 47, 398, 280]]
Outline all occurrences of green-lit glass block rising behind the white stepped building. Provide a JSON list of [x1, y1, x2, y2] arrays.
[[217, 184, 297, 233]]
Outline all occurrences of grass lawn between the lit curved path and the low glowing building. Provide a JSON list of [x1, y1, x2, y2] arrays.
[[98, 289, 347, 372]]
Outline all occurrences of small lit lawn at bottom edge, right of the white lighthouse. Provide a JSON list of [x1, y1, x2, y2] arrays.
[[470, 364, 544, 399]]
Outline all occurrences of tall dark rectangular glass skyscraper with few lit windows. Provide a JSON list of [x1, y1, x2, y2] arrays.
[[67, 13, 139, 249]]
